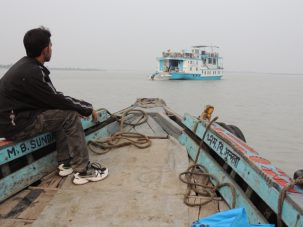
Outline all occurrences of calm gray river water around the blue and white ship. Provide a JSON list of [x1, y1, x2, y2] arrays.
[[0, 70, 303, 176]]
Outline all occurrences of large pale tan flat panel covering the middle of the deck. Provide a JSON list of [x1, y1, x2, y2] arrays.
[[33, 131, 221, 226]]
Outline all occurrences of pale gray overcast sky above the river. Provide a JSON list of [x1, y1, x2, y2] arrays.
[[0, 0, 303, 73]]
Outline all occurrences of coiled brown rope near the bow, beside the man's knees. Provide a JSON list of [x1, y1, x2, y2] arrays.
[[87, 109, 168, 154]]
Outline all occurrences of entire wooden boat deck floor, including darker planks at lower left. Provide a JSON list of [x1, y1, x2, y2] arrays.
[[0, 112, 227, 226]]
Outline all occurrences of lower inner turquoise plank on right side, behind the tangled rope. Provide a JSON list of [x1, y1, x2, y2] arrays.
[[179, 133, 267, 224]]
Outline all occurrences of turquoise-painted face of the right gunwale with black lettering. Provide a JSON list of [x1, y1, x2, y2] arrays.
[[183, 114, 303, 226]]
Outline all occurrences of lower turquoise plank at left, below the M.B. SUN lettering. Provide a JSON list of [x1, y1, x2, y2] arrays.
[[0, 152, 58, 202]]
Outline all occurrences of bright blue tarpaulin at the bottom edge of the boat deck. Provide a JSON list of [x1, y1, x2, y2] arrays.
[[191, 208, 275, 227]]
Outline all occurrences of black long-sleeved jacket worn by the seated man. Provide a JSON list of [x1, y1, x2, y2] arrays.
[[0, 57, 93, 138]]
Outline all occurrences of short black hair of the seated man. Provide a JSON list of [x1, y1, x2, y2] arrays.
[[23, 27, 51, 58]]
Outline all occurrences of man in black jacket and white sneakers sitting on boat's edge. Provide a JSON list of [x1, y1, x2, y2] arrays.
[[0, 27, 108, 184]]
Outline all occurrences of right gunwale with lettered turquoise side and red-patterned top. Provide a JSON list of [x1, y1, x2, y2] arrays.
[[183, 114, 303, 226]]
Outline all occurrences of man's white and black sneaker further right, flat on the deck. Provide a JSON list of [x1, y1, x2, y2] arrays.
[[73, 163, 108, 185]]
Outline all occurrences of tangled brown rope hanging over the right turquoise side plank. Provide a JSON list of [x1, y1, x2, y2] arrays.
[[179, 117, 236, 208]]
